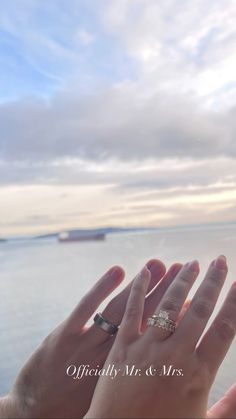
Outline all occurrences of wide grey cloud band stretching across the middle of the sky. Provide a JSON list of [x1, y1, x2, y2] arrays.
[[0, 86, 236, 169]]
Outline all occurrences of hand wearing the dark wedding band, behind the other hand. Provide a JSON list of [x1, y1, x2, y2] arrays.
[[0, 260, 184, 418]]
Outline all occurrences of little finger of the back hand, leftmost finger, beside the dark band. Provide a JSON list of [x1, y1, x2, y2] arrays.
[[67, 266, 125, 331]]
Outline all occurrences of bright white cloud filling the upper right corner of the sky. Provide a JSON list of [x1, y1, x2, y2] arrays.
[[101, 0, 236, 103]]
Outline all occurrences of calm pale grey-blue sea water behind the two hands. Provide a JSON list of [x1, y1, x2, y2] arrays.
[[0, 225, 236, 403]]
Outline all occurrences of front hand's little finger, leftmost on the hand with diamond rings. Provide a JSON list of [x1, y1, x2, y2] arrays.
[[119, 266, 151, 340]]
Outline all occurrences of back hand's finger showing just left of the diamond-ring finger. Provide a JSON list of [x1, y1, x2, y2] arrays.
[[142, 263, 182, 331]]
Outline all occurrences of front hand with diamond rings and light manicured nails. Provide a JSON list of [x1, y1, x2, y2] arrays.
[[86, 256, 236, 418]]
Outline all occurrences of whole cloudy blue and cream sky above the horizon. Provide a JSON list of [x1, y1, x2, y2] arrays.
[[0, 0, 236, 237]]
